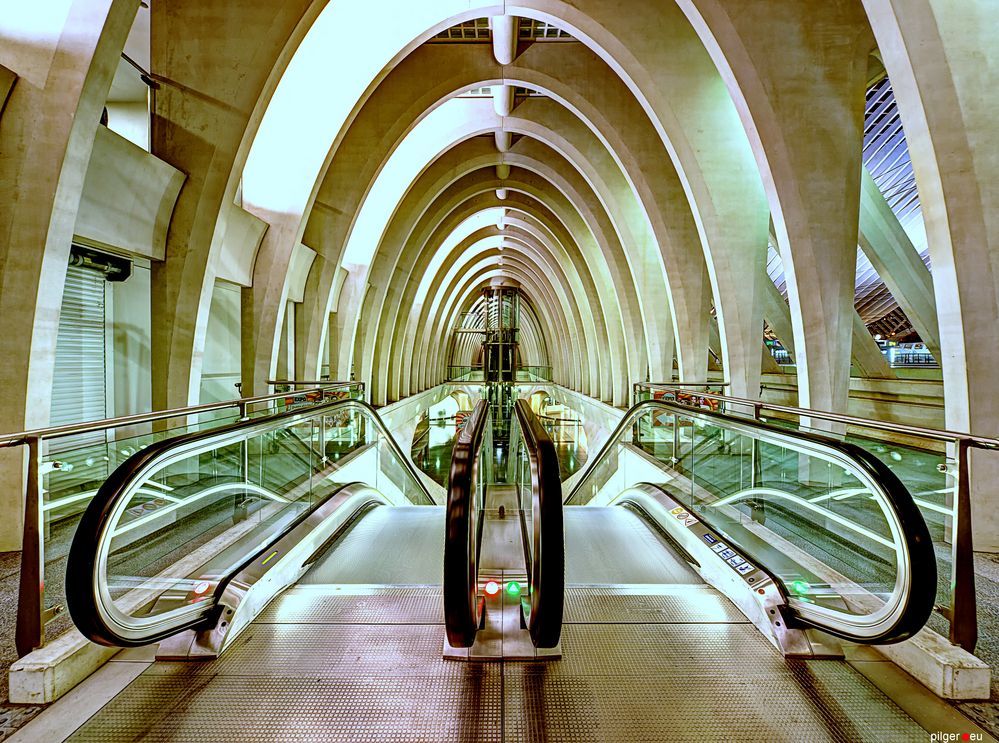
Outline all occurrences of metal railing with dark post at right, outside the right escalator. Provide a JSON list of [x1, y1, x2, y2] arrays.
[[634, 382, 999, 652]]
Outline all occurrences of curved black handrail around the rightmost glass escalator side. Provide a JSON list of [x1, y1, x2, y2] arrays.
[[565, 400, 936, 642]]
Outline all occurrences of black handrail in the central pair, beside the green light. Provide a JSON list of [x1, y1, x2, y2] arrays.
[[514, 399, 565, 648]]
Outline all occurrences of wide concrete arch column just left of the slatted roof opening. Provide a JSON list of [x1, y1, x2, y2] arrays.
[[678, 0, 874, 412]]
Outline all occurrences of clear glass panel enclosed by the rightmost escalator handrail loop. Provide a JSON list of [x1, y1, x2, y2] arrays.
[[572, 404, 928, 640]]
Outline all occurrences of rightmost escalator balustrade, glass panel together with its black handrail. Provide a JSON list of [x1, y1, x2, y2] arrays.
[[565, 400, 936, 643]]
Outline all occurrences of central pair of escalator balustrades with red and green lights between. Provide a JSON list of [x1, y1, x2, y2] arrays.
[[444, 400, 565, 660]]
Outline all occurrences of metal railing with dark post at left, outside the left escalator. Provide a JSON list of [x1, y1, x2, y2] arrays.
[[0, 381, 364, 657]]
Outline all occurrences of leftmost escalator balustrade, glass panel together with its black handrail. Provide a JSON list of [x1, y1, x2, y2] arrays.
[[66, 399, 433, 647]]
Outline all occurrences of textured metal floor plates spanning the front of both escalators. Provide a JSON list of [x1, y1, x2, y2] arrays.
[[62, 540, 928, 743]]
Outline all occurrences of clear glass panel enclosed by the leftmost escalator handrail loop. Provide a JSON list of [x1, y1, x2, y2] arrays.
[[86, 403, 429, 633]]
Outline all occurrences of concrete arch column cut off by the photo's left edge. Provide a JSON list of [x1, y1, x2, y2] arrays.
[[0, 0, 138, 551]]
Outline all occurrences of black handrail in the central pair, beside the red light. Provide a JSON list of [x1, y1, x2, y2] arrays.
[[443, 400, 489, 648]]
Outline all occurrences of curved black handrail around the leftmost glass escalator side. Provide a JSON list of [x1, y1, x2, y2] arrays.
[[66, 399, 433, 644]]
